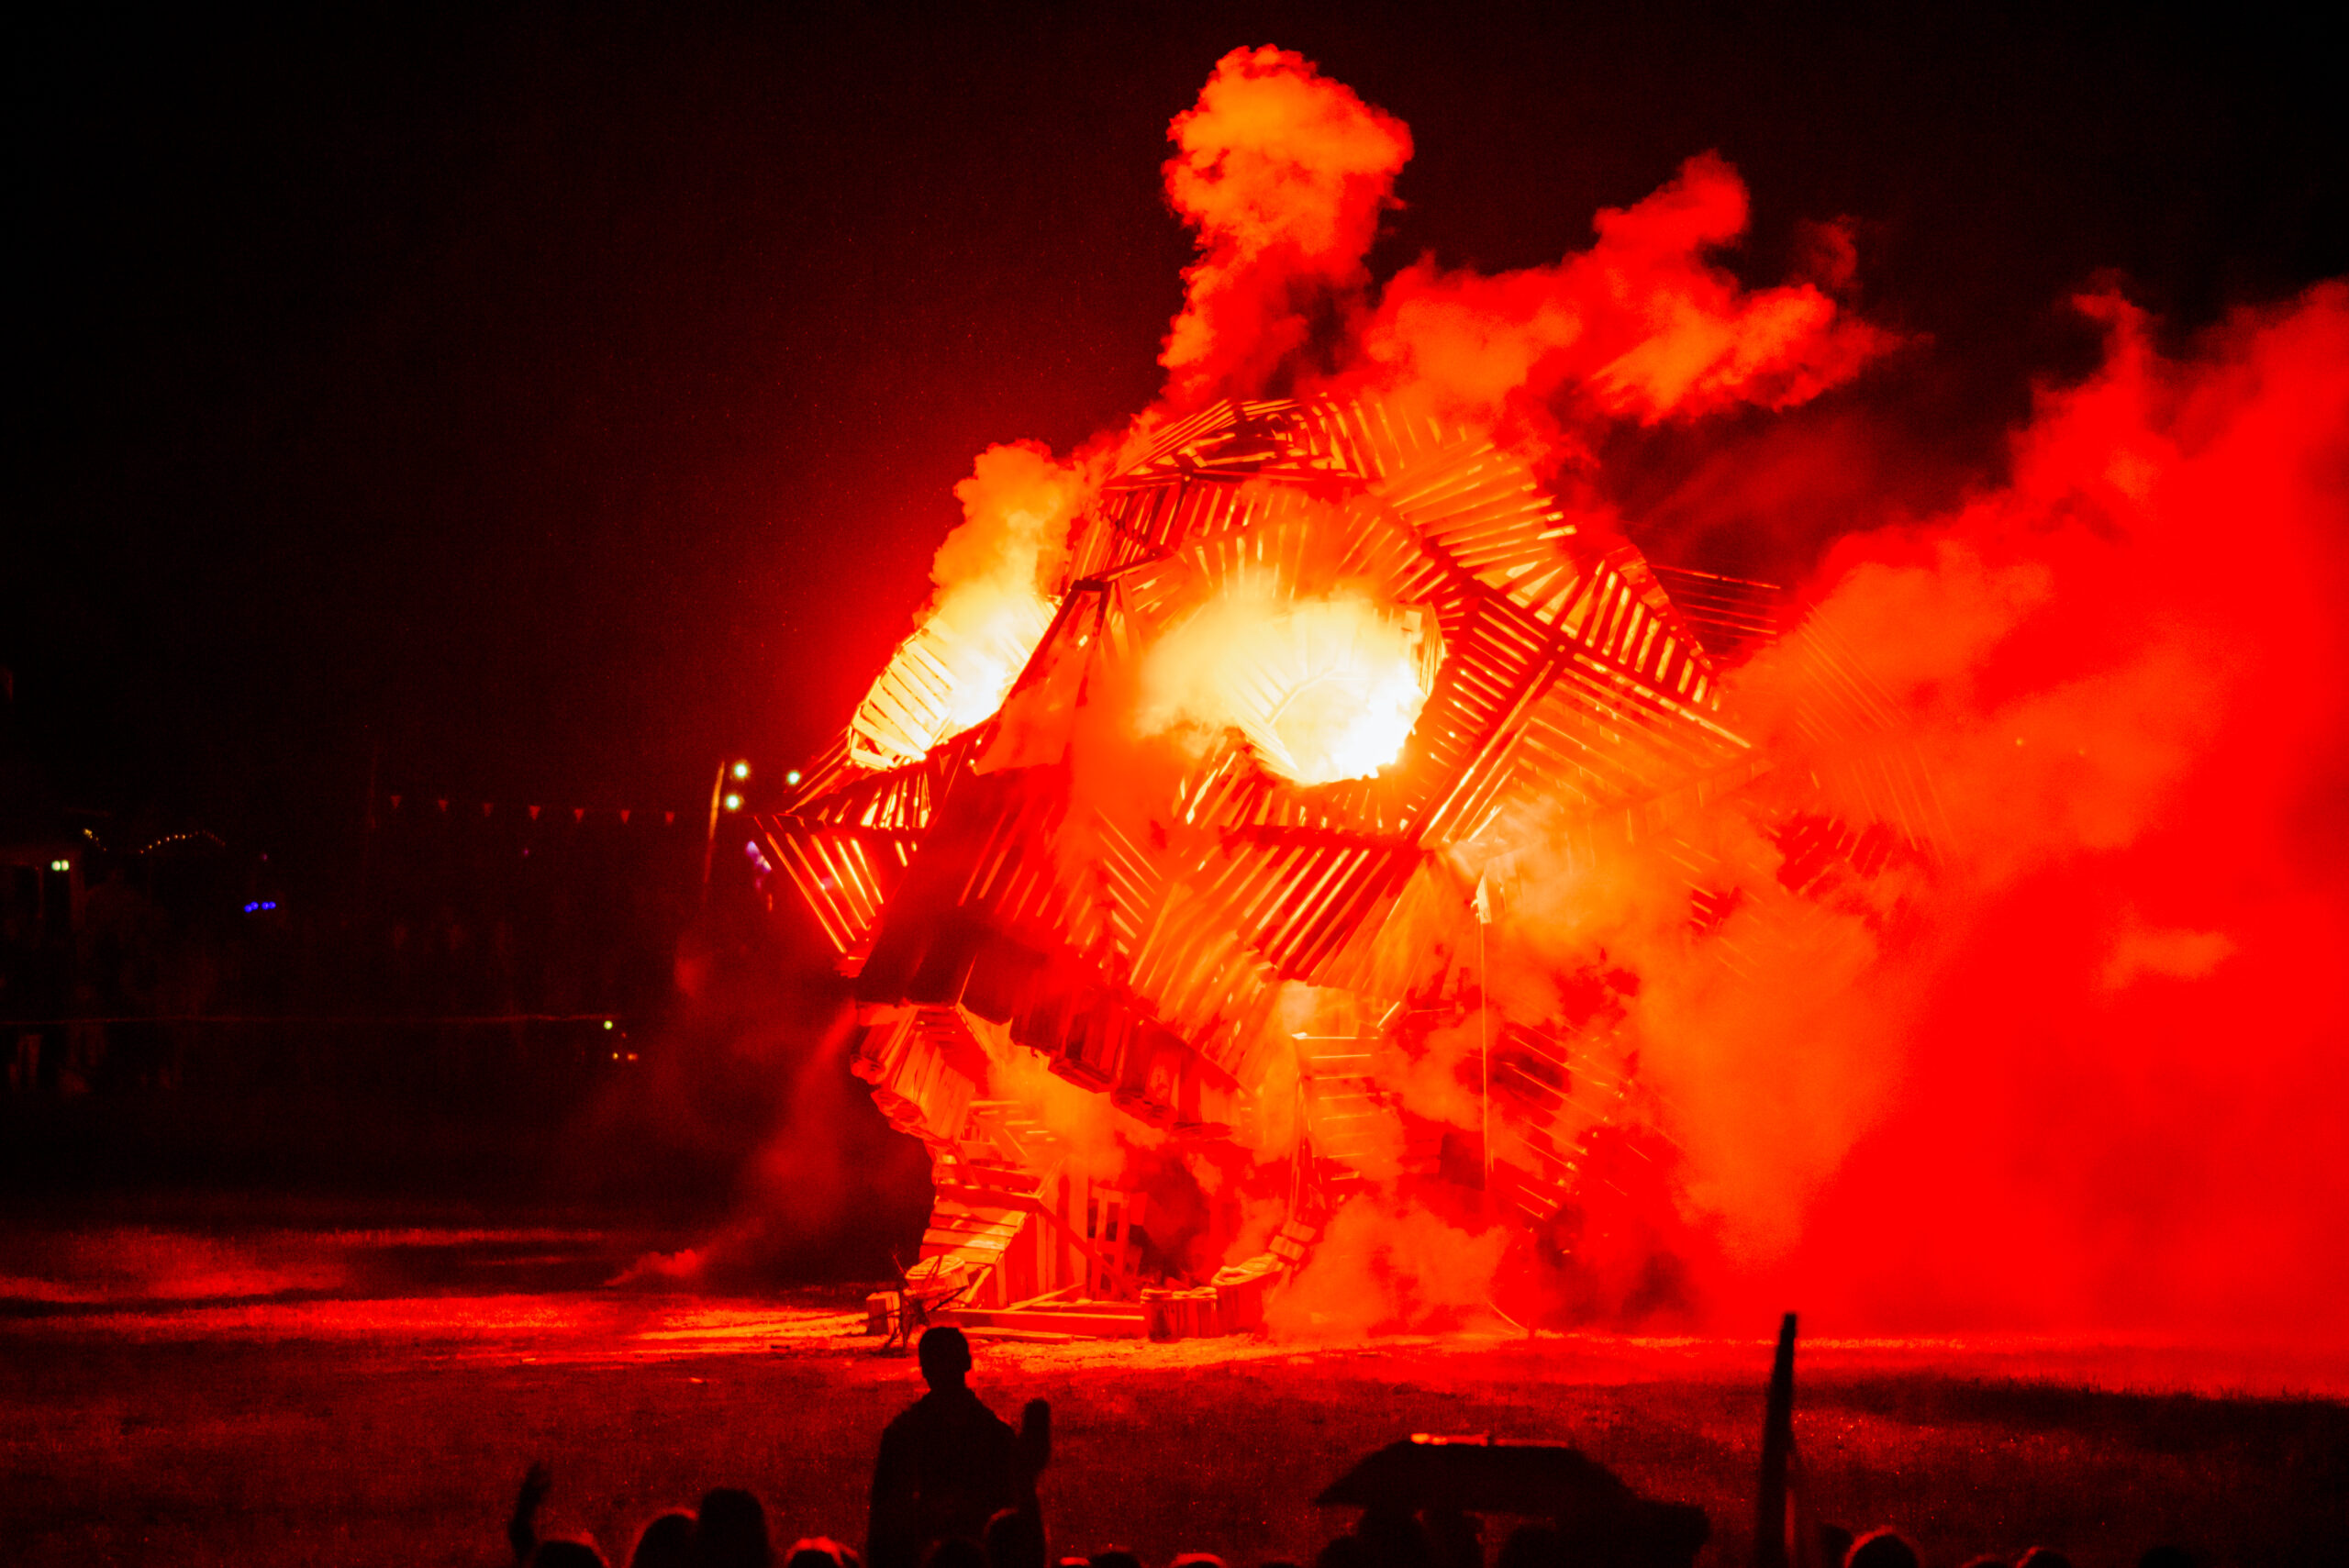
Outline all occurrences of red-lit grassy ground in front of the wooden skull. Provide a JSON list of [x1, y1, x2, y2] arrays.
[[0, 1225, 2349, 1565]]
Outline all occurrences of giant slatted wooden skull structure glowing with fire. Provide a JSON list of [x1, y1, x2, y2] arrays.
[[761, 399, 1851, 1333]]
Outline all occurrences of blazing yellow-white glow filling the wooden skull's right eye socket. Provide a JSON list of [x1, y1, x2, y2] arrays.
[[1144, 580, 1442, 784]]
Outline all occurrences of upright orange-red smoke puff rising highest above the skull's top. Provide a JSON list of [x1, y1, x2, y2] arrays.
[[1158, 47, 1412, 406]]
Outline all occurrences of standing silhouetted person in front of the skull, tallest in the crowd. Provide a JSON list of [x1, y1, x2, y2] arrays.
[[864, 1326, 1052, 1568]]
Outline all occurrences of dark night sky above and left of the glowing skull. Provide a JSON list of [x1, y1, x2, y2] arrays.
[[0, 5, 2349, 863]]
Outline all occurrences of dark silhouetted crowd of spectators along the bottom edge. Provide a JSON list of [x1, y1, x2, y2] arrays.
[[507, 1326, 2201, 1568]]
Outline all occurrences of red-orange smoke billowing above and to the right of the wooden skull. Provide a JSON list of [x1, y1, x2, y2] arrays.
[[869, 47, 2349, 1336]]
